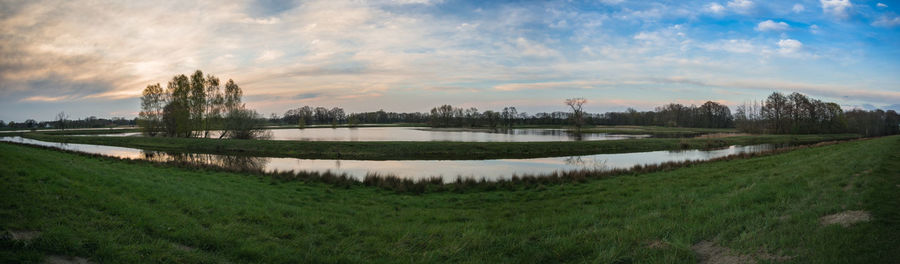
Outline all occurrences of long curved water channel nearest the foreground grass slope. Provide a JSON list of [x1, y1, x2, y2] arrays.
[[0, 137, 773, 181]]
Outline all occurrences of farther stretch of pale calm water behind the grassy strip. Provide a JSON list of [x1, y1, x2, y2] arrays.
[[84, 127, 649, 142]]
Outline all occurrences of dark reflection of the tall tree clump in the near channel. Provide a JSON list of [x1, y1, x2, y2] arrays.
[[143, 151, 270, 171]]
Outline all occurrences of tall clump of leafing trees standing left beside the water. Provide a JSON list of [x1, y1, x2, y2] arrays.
[[137, 70, 264, 139]]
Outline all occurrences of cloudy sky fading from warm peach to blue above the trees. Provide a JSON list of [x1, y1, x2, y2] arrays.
[[0, 0, 900, 122]]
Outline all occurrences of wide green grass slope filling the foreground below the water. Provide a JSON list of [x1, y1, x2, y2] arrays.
[[0, 136, 900, 263]]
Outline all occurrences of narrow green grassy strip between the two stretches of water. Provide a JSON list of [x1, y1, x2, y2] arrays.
[[17, 133, 858, 160]]
